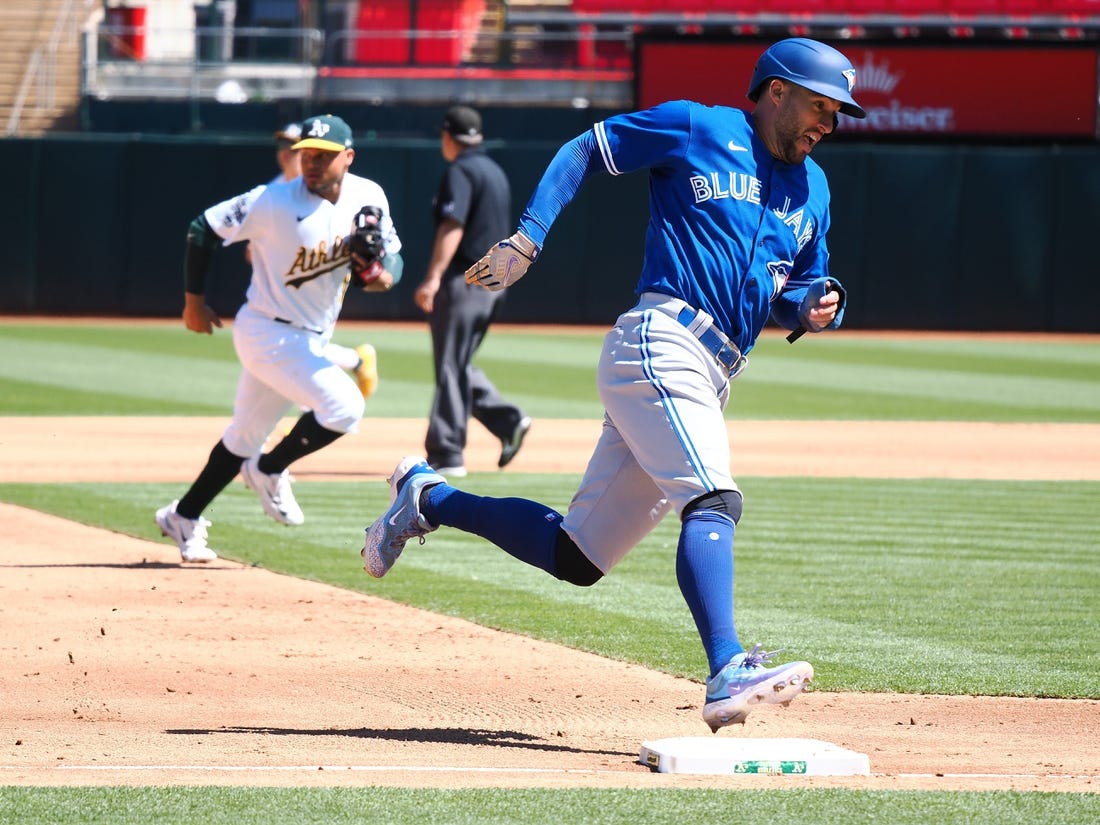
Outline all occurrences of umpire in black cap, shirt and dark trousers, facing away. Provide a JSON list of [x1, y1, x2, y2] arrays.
[[414, 106, 531, 476]]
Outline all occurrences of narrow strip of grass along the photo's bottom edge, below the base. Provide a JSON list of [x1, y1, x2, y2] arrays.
[[0, 787, 1100, 825]]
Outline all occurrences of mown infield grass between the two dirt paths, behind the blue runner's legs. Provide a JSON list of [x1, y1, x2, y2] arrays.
[[0, 473, 1100, 697]]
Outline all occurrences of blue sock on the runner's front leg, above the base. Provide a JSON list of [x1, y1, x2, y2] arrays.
[[677, 510, 745, 677]]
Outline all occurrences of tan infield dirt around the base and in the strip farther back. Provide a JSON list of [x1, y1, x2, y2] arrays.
[[0, 418, 1100, 792]]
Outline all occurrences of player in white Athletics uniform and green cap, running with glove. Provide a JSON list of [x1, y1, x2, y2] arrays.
[[155, 114, 404, 562]]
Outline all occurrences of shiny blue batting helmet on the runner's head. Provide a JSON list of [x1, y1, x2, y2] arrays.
[[749, 37, 867, 118]]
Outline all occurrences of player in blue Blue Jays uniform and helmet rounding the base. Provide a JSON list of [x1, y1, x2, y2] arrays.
[[362, 37, 866, 732]]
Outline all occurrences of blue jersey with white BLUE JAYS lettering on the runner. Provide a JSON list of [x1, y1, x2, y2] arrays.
[[520, 100, 829, 352]]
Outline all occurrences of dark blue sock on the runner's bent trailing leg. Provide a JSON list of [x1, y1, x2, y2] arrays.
[[420, 484, 561, 575]]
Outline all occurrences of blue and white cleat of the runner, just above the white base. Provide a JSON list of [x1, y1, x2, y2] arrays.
[[703, 645, 814, 734]]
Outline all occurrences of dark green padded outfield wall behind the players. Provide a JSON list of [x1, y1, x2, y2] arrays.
[[0, 133, 1100, 332]]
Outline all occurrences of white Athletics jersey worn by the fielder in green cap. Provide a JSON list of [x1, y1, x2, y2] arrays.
[[204, 173, 402, 332]]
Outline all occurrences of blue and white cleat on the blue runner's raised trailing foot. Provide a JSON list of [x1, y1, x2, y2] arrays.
[[360, 455, 447, 579]]
